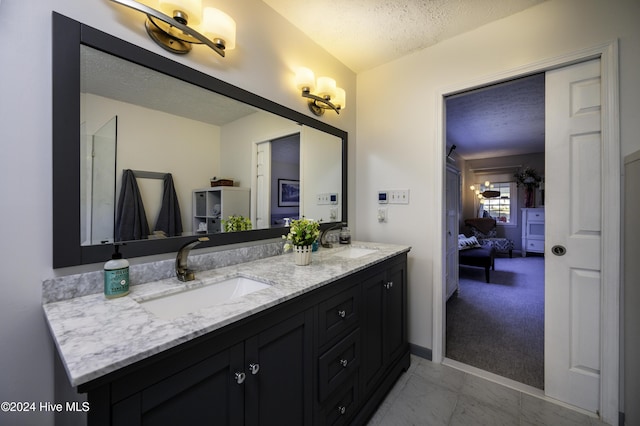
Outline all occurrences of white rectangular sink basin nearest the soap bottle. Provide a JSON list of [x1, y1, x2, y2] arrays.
[[140, 276, 270, 319]]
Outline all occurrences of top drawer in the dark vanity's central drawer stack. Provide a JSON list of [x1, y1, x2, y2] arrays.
[[318, 286, 360, 346]]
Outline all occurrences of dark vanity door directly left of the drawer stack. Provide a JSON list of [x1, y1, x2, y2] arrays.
[[245, 310, 313, 425]]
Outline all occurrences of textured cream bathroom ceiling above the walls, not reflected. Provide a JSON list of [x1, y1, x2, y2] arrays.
[[263, 0, 544, 73]]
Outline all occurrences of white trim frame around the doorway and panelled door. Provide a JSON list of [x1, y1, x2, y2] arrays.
[[432, 39, 622, 424]]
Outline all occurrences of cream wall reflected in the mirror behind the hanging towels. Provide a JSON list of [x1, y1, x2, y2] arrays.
[[81, 94, 220, 233]]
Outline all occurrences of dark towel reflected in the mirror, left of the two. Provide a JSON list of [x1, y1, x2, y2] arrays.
[[115, 169, 149, 241]]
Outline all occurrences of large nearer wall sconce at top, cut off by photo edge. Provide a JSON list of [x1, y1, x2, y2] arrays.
[[111, 0, 236, 57]]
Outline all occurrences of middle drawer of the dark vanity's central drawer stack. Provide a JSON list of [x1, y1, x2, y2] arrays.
[[318, 329, 360, 401]]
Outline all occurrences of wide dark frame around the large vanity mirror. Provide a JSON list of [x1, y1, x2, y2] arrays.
[[52, 12, 348, 268]]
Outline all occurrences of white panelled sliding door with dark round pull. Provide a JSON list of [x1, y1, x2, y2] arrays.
[[545, 59, 600, 412]]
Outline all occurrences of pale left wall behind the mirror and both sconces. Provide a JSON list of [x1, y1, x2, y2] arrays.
[[0, 0, 356, 425]]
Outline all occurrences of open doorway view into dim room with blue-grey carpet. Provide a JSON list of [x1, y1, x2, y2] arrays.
[[445, 73, 545, 390]]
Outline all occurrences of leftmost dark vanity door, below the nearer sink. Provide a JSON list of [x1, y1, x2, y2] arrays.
[[111, 344, 244, 426]]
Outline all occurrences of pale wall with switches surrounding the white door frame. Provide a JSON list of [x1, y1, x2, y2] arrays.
[[355, 0, 640, 348]]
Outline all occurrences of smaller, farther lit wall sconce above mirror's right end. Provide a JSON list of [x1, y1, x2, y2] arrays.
[[296, 68, 347, 116]]
